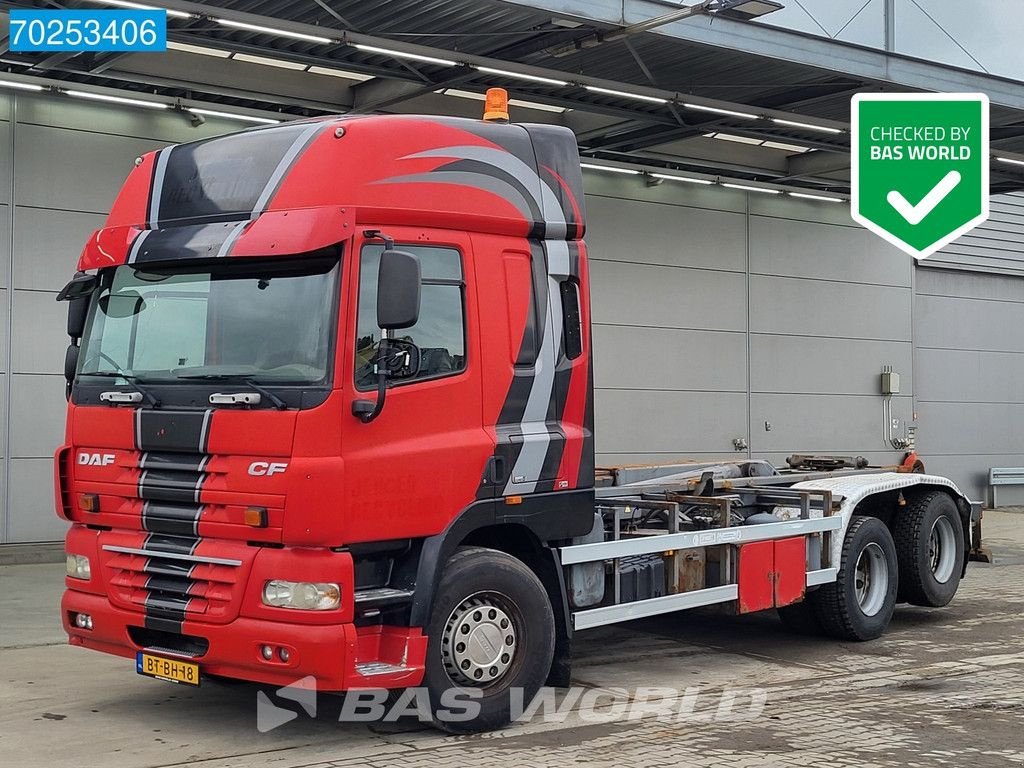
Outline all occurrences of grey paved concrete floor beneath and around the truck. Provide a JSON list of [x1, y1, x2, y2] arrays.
[[0, 512, 1024, 768]]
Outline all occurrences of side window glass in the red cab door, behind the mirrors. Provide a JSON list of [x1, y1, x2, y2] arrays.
[[355, 243, 466, 389]]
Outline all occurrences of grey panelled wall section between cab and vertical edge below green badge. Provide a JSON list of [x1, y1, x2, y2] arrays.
[[586, 171, 913, 475]]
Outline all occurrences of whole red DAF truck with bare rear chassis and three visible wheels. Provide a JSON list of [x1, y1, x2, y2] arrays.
[[55, 94, 973, 731]]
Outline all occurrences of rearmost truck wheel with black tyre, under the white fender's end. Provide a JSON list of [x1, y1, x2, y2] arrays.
[[893, 490, 964, 608]]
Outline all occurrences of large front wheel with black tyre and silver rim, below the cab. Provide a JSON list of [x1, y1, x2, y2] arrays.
[[424, 547, 555, 733]]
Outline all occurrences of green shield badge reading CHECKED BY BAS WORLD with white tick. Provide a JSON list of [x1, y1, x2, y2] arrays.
[[850, 93, 988, 259]]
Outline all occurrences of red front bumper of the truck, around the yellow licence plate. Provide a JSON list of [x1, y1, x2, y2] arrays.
[[60, 589, 426, 691]]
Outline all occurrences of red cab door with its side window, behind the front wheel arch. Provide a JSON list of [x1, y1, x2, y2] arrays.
[[339, 226, 493, 543]]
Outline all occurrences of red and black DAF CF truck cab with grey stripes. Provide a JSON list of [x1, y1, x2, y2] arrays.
[[56, 111, 594, 724]]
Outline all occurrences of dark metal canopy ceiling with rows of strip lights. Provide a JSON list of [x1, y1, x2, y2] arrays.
[[0, 0, 1024, 196]]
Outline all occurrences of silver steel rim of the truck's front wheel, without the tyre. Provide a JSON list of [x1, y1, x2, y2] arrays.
[[441, 592, 521, 688]]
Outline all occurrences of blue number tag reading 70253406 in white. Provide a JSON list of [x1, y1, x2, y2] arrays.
[[9, 8, 167, 53]]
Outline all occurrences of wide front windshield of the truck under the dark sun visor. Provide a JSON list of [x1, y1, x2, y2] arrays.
[[78, 258, 339, 384]]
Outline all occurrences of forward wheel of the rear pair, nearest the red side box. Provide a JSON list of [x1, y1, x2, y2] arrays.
[[811, 516, 899, 640]]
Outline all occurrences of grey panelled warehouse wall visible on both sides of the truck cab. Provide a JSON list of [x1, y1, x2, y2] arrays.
[[0, 92, 1024, 543]]
